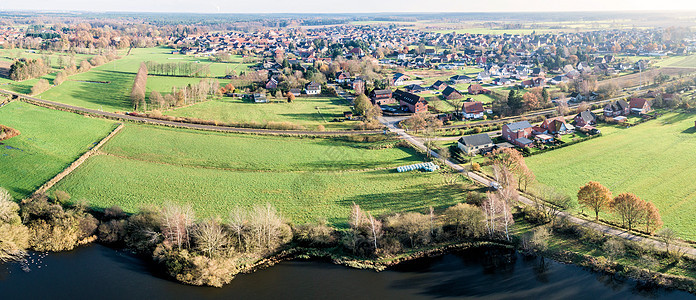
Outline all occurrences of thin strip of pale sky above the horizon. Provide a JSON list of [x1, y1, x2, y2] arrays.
[[0, 0, 696, 13]]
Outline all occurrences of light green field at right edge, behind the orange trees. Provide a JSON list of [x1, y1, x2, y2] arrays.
[[527, 113, 696, 240]]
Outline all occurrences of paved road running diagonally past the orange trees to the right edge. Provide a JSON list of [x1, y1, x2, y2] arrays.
[[380, 117, 696, 256]]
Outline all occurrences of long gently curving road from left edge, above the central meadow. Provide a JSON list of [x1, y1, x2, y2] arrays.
[[0, 90, 383, 135]]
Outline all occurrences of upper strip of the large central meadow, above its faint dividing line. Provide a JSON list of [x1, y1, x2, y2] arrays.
[[102, 125, 422, 171]]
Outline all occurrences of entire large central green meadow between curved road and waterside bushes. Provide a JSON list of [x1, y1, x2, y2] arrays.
[[54, 125, 465, 226]]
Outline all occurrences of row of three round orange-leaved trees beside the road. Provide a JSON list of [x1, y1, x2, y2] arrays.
[[578, 181, 663, 234]]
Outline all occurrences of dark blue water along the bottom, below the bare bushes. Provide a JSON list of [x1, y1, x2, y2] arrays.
[[0, 245, 694, 300]]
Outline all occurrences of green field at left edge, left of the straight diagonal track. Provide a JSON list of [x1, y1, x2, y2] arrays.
[[0, 101, 115, 198]]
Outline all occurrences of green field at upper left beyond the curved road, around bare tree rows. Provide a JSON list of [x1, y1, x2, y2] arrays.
[[34, 48, 254, 111]]
